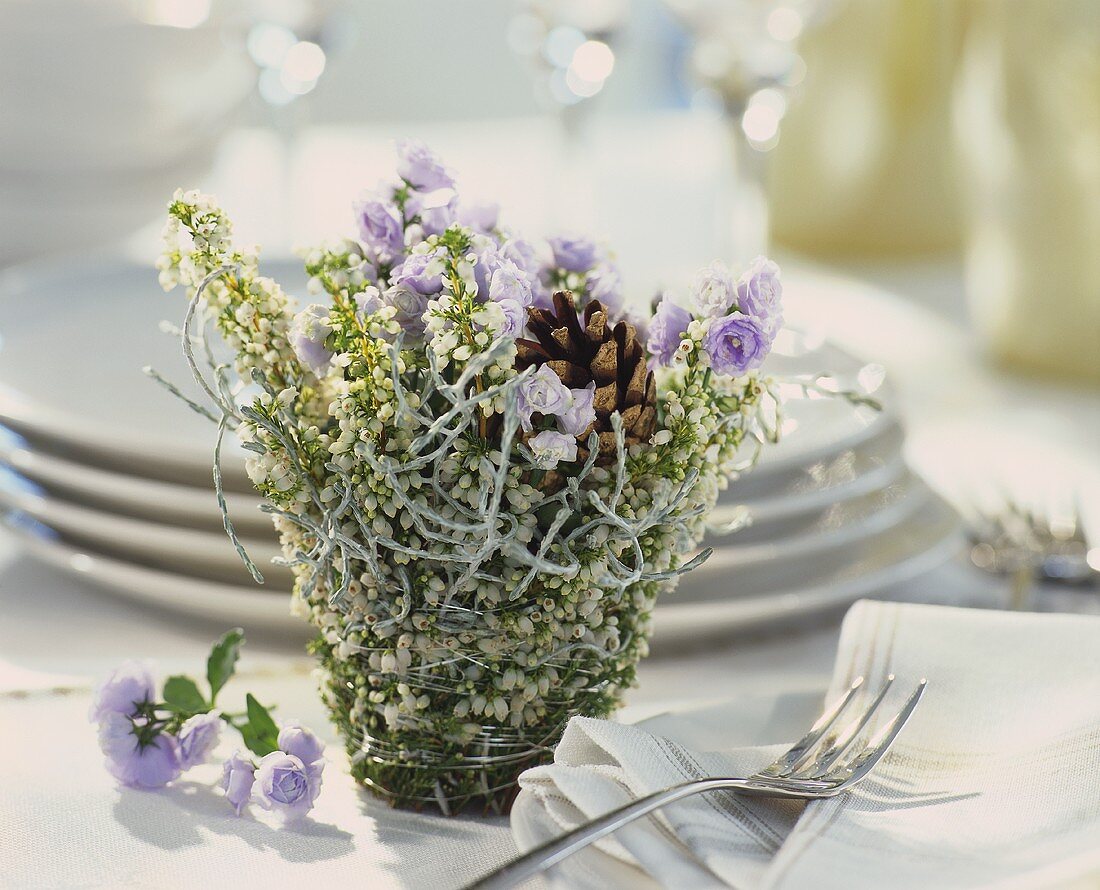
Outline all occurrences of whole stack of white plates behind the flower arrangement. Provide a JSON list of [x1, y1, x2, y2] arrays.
[[0, 255, 958, 647]]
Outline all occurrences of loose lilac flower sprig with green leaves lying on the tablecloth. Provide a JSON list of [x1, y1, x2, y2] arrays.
[[88, 628, 325, 824]]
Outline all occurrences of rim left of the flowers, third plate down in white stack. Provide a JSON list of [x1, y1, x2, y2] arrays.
[[0, 470, 292, 593]]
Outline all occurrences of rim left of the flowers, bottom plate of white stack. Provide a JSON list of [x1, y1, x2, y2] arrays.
[[3, 515, 310, 639]]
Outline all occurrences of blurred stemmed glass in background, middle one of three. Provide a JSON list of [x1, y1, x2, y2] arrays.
[[508, 0, 630, 230]]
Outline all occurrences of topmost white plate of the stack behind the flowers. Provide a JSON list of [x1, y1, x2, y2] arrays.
[[0, 257, 892, 492]]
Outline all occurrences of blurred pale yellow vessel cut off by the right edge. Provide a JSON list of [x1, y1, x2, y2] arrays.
[[955, 0, 1100, 385]]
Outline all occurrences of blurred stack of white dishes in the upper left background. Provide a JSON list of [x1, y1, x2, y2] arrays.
[[0, 0, 254, 263]]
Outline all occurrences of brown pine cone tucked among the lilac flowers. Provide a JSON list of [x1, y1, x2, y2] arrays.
[[516, 290, 657, 463]]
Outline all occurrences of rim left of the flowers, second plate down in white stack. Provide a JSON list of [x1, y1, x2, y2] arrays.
[[0, 427, 273, 537]]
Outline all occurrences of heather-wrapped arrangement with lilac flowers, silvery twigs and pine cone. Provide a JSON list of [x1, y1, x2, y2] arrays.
[[157, 142, 782, 813]]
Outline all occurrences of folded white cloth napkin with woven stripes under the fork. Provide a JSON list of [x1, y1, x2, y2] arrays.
[[513, 602, 1100, 890]]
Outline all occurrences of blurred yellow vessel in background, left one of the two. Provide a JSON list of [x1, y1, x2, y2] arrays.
[[769, 0, 966, 256]]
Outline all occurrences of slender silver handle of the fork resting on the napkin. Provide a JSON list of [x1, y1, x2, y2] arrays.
[[466, 779, 785, 890]]
